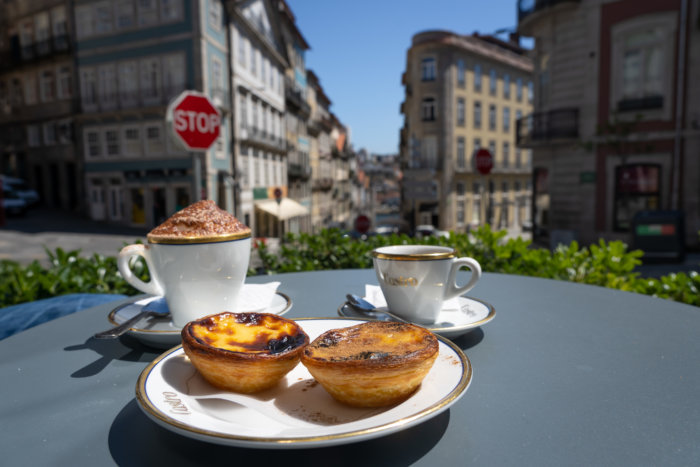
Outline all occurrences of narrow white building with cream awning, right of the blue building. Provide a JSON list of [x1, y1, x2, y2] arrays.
[[227, 0, 292, 237]]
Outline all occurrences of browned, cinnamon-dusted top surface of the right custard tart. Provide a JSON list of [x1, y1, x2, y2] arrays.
[[302, 321, 439, 366]]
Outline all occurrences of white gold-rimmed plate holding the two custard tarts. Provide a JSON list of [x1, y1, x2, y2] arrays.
[[136, 318, 472, 449]]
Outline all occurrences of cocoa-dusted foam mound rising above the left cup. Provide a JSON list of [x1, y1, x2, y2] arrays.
[[147, 200, 251, 244]]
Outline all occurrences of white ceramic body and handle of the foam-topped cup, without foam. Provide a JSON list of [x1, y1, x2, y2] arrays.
[[117, 233, 251, 327]]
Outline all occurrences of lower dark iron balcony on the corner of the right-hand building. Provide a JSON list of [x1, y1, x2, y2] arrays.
[[516, 109, 578, 148]]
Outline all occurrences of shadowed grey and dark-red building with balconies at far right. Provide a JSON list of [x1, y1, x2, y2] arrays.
[[518, 0, 700, 249]]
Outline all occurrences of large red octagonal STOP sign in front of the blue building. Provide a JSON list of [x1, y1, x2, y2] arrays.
[[167, 91, 221, 151]]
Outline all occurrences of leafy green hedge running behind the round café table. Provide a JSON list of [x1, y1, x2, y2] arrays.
[[0, 226, 700, 307]]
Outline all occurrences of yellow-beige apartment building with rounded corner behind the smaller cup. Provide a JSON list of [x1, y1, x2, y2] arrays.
[[399, 31, 533, 233]]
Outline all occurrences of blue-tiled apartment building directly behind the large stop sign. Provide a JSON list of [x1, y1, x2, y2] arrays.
[[74, 0, 233, 228]]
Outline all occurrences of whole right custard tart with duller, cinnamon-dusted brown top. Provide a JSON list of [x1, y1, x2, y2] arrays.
[[301, 321, 439, 407]]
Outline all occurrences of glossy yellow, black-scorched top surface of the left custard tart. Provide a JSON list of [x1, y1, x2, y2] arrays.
[[182, 312, 309, 356]]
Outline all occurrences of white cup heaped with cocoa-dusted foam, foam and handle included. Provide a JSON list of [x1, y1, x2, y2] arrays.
[[117, 201, 251, 328]]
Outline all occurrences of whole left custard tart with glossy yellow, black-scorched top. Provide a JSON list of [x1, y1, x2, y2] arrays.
[[182, 312, 309, 394]]
